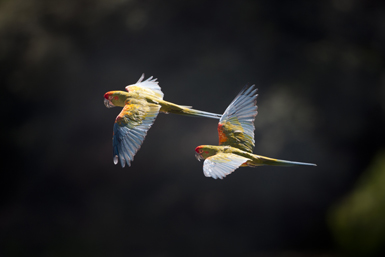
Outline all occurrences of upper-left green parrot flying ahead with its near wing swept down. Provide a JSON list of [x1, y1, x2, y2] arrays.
[[104, 74, 221, 168]]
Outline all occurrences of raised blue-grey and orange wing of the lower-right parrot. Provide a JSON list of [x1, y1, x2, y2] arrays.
[[218, 85, 258, 153]]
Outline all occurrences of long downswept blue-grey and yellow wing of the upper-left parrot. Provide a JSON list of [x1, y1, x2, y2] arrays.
[[112, 100, 160, 168]]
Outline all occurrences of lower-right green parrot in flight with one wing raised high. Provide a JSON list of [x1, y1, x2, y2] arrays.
[[195, 85, 317, 179]]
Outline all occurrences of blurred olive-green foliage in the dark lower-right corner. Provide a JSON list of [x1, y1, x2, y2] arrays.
[[329, 151, 385, 256]]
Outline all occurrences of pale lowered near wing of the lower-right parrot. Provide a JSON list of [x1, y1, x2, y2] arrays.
[[203, 153, 249, 179]]
